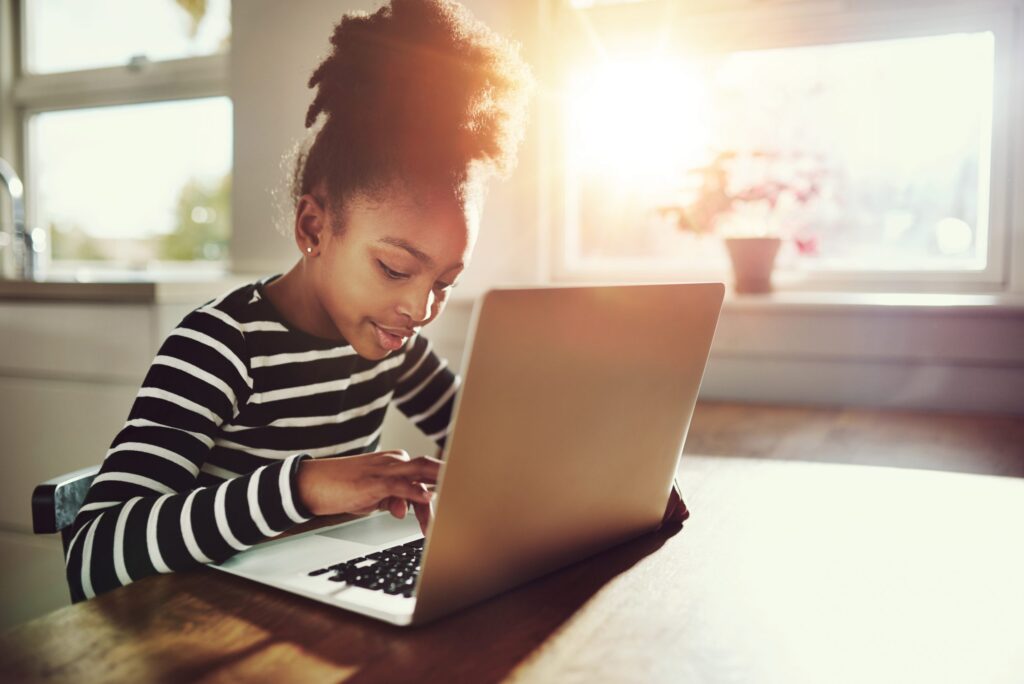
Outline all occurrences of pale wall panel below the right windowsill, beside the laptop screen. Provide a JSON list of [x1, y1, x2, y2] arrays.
[[700, 295, 1024, 411]]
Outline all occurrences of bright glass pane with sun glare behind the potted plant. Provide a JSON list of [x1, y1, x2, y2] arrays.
[[565, 33, 994, 270]]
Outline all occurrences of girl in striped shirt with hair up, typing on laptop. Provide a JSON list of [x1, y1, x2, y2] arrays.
[[67, 0, 684, 600]]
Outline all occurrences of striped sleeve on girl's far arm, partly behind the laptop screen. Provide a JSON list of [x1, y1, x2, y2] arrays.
[[392, 336, 460, 447]]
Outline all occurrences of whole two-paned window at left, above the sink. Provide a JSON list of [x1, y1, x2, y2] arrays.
[[3, 0, 232, 277]]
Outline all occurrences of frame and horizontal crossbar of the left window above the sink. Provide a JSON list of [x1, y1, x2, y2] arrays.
[[0, 0, 230, 271]]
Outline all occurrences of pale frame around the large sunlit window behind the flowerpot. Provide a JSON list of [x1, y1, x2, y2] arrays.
[[546, 0, 1024, 293]]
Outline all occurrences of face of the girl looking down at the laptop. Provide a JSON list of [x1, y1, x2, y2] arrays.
[[309, 184, 478, 359]]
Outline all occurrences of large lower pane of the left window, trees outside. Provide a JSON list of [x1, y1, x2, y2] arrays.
[[28, 97, 231, 268]]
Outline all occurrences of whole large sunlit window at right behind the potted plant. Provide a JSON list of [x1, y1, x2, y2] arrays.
[[556, 2, 1014, 289]]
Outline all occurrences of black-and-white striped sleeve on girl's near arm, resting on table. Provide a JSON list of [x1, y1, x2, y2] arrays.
[[67, 302, 311, 601]]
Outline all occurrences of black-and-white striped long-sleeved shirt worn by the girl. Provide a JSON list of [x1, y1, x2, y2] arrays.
[[67, 275, 459, 601]]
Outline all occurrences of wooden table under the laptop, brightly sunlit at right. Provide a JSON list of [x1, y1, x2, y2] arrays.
[[0, 457, 1024, 684]]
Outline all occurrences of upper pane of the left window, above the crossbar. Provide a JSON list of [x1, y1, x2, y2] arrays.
[[24, 0, 230, 74]]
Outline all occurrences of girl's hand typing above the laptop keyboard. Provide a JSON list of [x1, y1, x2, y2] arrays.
[[296, 451, 440, 532]]
